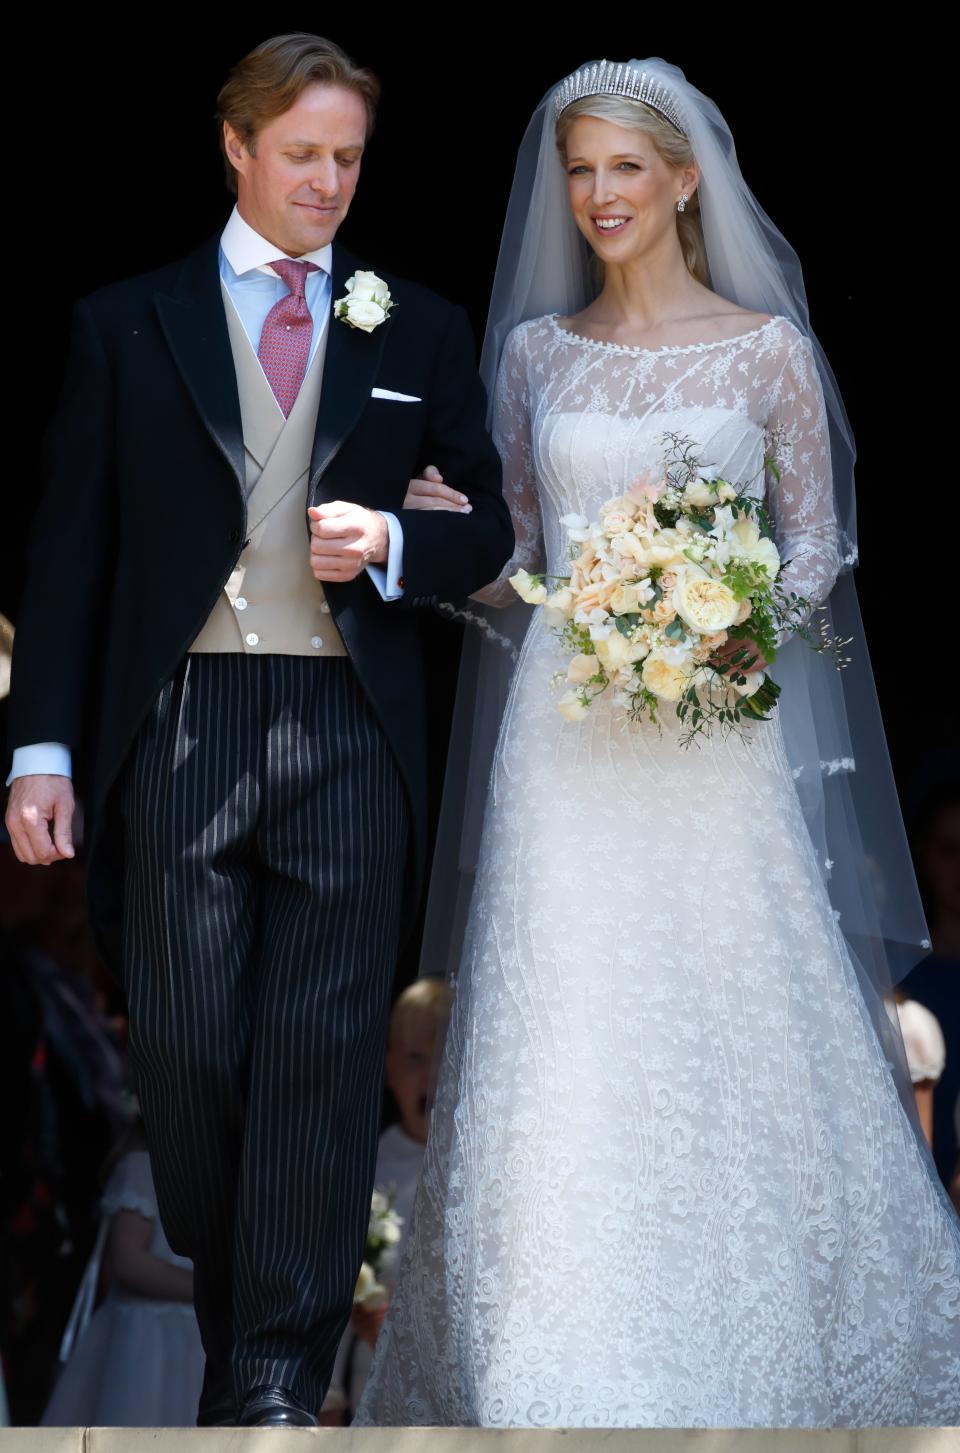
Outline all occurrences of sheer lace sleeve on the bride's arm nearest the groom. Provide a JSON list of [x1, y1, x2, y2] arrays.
[[471, 323, 545, 606]]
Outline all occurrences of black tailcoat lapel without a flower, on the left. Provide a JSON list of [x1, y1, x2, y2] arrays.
[[155, 238, 244, 490]]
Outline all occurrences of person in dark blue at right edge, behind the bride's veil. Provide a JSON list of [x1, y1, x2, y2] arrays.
[[900, 773, 960, 1187]]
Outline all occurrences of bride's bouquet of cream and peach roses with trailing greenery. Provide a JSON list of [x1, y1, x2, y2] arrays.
[[511, 434, 812, 744]]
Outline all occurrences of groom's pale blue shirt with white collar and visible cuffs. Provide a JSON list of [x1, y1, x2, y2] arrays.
[[7, 206, 404, 785]]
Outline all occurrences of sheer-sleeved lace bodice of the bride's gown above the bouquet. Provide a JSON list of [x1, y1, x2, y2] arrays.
[[476, 315, 839, 616]]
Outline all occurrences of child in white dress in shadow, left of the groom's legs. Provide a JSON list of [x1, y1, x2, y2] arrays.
[[44, 1116, 203, 1428]]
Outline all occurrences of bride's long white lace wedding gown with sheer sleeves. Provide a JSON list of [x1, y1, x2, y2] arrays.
[[357, 317, 960, 1427]]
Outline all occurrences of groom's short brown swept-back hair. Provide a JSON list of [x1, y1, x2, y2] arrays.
[[216, 31, 381, 193]]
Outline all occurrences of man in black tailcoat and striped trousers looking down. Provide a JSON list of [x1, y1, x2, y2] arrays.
[[7, 35, 513, 1425]]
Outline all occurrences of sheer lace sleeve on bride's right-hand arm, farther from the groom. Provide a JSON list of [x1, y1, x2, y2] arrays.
[[767, 324, 839, 627]]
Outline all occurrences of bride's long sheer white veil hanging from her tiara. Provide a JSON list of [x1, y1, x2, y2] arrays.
[[421, 58, 930, 1121]]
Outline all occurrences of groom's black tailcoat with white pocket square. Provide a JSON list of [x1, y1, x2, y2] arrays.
[[10, 240, 513, 959]]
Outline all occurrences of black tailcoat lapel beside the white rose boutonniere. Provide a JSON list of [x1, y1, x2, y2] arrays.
[[309, 243, 391, 504]]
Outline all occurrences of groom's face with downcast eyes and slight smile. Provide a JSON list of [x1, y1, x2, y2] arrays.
[[224, 86, 367, 257]]
